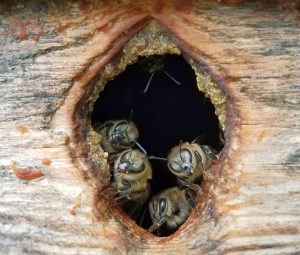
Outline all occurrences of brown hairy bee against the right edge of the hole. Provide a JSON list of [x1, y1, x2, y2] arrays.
[[168, 142, 218, 186]]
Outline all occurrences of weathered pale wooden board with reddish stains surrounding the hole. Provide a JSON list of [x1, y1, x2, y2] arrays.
[[0, 1, 300, 255]]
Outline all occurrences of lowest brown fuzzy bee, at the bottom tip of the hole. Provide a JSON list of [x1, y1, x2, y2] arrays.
[[148, 185, 200, 233]]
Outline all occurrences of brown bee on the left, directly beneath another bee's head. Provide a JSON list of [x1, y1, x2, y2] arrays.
[[113, 149, 152, 213]]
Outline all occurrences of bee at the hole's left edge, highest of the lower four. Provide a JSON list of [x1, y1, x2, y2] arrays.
[[95, 120, 144, 153]]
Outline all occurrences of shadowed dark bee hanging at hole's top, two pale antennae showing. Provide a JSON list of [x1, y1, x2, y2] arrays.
[[139, 55, 181, 93]]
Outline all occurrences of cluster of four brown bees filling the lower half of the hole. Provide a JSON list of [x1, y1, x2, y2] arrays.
[[95, 120, 217, 234]]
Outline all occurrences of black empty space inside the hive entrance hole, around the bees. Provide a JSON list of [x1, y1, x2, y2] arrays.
[[91, 55, 222, 236]]
